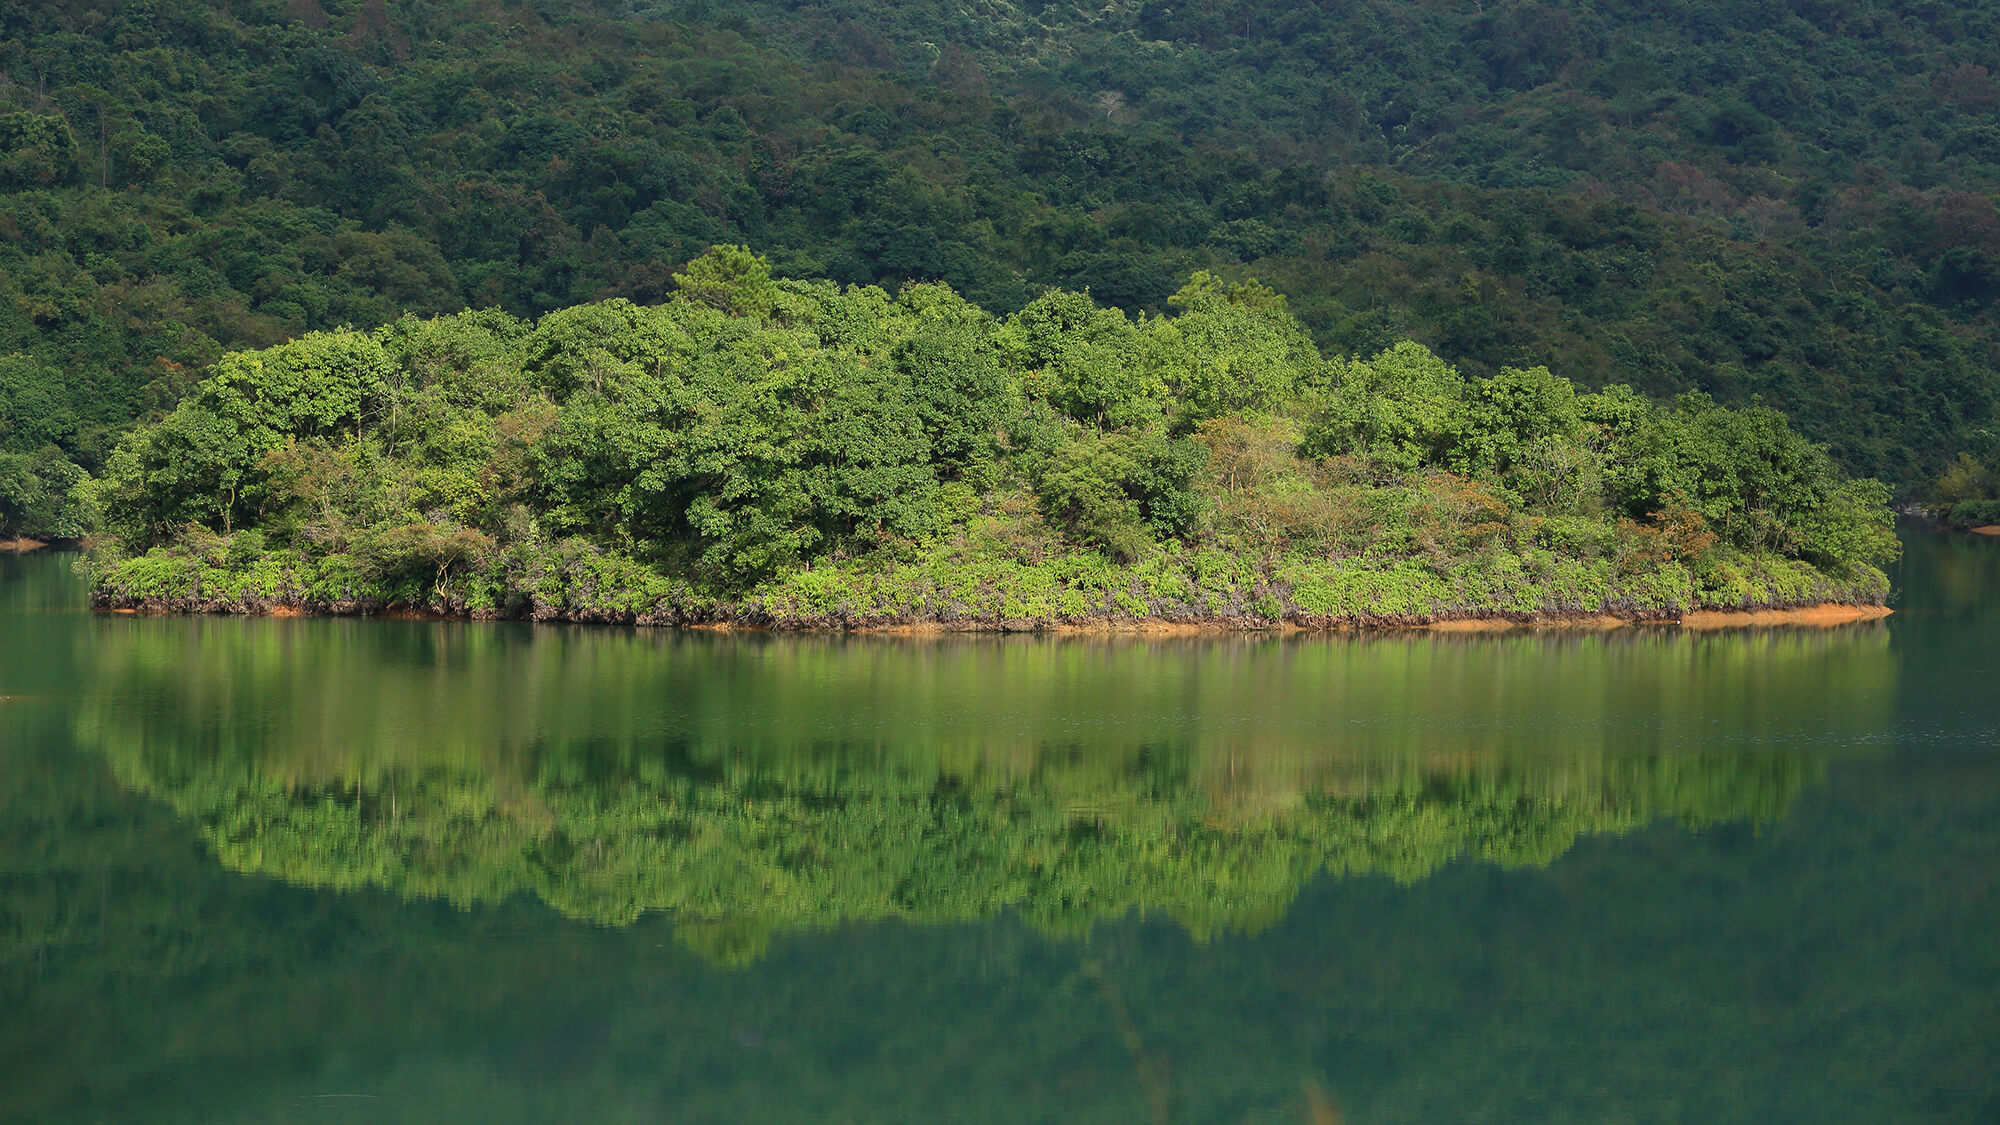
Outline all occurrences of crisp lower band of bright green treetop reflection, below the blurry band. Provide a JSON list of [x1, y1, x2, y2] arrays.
[[101, 732, 1820, 961]]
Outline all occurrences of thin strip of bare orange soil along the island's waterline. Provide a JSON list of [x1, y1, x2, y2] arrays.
[[90, 593, 1894, 637]]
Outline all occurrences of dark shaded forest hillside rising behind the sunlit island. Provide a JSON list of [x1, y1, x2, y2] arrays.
[[0, 0, 2000, 530]]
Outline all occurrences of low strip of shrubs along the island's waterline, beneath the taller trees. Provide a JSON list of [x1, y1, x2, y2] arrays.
[[92, 528, 1888, 633]]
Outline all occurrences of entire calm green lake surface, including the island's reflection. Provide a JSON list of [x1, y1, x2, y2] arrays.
[[0, 530, 2000, 1125]]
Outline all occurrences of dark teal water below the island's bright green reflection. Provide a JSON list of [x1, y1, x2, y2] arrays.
[[0, 728, 2000, 1123]]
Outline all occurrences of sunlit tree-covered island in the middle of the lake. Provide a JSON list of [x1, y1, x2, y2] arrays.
[[80, 246, 1896, 627]]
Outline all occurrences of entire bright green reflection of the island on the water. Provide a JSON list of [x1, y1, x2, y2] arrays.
[[80, 619, 1890, 957]]
